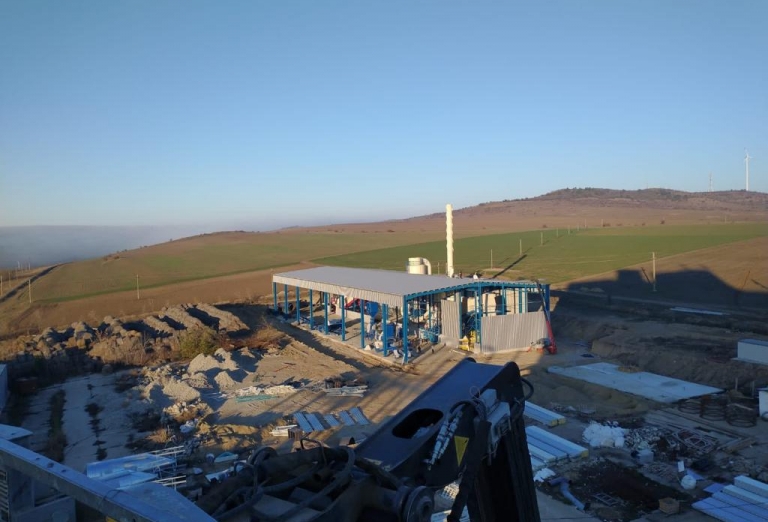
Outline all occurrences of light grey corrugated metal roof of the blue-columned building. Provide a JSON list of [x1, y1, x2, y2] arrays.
[[272, 266, 486, 306]]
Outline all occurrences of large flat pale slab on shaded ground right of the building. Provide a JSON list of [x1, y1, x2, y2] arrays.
[[549, 363, 723, 403]]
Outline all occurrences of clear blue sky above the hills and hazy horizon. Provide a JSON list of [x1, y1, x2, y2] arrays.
[[0, 0, 768, 229]]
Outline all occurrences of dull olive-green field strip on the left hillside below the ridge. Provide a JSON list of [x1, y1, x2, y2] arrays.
[[33, 232, 434, 302]]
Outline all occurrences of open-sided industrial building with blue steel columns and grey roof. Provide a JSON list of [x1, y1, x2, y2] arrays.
[[272, 265, 551, 362]]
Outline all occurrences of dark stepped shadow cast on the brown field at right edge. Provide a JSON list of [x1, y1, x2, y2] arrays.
[[567, 268, 768, 313]]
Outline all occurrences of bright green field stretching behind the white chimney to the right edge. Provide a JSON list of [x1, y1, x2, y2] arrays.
[[314, 223, 768, 283]]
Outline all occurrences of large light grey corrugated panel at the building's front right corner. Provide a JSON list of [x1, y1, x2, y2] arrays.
[[480, 312, 549, 353]]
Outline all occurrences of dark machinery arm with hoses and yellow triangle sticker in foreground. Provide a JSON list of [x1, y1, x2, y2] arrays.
[[198, 359, 539, 522]]
